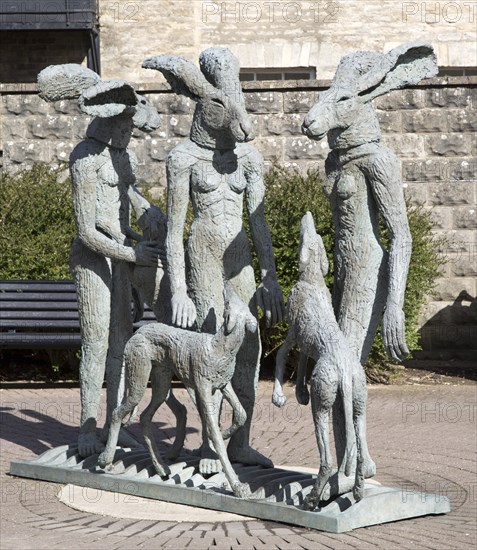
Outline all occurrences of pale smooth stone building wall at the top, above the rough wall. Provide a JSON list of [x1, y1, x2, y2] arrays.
[[100, 0, 477, 83]]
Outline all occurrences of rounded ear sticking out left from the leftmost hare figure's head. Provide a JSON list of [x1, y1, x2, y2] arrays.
[[37, 63, 100, 101]]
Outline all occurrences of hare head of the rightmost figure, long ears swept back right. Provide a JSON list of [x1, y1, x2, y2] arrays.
[[302, 41, 438, 148]]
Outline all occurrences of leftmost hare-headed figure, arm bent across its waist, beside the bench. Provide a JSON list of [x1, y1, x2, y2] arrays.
[[38, 64, 161, 456]]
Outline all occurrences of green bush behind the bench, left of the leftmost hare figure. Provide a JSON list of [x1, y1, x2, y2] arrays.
[[0, 164, 76, 279]]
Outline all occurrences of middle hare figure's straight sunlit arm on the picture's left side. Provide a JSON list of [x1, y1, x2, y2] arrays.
[[166, 151, 196, 328]]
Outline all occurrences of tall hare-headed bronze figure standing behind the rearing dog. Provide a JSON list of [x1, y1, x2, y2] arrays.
[[302, 42, 437, 477]]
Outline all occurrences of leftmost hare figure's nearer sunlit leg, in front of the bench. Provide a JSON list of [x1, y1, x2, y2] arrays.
[[71, 244, 111, 457]]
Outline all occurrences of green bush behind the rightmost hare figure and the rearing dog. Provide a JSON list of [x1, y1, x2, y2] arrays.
[[256, 165, 442, 379]]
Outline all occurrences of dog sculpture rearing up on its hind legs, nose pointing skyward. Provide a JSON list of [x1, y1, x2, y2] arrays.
[[272, 212, 367, 509]]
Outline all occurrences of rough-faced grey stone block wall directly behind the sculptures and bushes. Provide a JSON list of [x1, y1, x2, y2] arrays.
[[0, 78, 477, 359]]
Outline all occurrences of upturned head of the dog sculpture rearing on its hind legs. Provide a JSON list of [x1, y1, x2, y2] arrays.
[[299, 212, 329, 281]]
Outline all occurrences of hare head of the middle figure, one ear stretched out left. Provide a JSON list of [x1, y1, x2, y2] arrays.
[[142, 47, 254, 149]]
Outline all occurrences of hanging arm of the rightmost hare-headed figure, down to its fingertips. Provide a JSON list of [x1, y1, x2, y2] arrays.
[[369, 149, 412, 361]]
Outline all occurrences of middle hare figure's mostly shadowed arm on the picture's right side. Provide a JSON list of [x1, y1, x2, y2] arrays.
[[245, 148, 284, 326]]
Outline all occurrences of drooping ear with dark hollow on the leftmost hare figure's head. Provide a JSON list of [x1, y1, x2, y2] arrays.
[[79, 80, 138, 118]]
